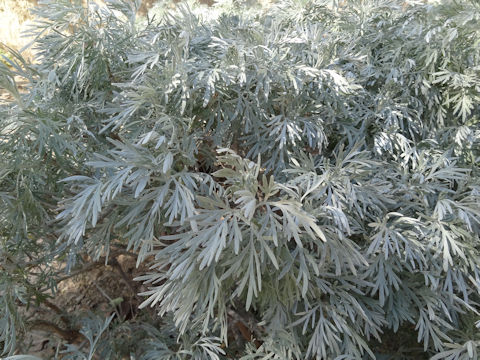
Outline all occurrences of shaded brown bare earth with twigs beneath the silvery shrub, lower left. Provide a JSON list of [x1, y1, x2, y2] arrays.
[[22, 254, 152, 359]]
